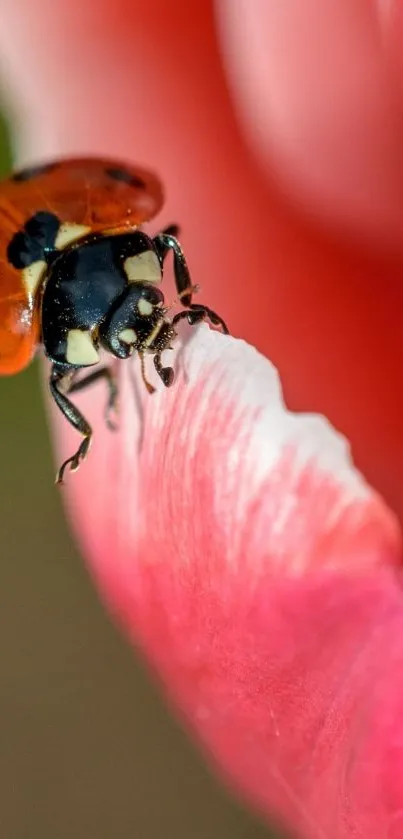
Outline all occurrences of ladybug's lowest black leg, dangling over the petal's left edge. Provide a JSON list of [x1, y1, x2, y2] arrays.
[[49, 364, 92, 484]]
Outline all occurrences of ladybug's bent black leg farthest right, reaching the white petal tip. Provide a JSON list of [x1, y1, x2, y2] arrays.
[[153, 233, 228, 335]]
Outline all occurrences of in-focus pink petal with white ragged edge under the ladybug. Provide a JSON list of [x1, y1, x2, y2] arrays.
[[49, 327, 403, 839]]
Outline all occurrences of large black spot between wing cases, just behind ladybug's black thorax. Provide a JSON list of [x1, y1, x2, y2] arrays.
[[7, 211, 60, 269]]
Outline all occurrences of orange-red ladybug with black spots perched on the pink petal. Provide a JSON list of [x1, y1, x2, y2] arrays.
[[0, 158, 228, 484]]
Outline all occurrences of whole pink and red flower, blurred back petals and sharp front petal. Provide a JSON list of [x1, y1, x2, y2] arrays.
[[2, 0, 403, 839]]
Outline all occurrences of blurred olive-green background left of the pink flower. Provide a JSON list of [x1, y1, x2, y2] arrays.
[[0, 110, 280, 839]]
